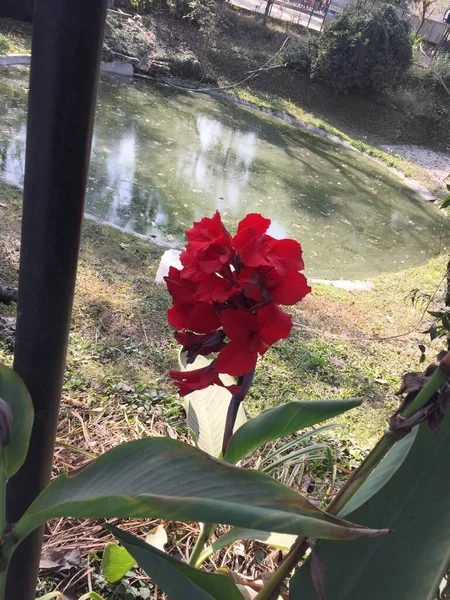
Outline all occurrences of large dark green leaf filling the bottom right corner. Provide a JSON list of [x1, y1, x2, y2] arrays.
[[291, 411, 450, 600]]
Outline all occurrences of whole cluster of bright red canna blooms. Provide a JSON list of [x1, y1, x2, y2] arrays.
[[165, 212, 311, 396]]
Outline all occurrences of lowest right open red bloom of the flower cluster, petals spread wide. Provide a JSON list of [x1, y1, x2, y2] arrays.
[[214, 303, 292, 376]]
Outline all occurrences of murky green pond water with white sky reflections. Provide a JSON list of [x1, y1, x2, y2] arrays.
[[0, 68, 449, 279]]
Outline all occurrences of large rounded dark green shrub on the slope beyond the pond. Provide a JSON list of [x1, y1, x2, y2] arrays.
[[310, 5, 412, 92]]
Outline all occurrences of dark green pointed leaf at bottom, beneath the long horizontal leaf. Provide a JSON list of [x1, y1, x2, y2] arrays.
[[106, 525, 242, 600]]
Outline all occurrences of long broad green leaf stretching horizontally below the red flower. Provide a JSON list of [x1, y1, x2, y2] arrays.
[[13, 438, 384, 540]]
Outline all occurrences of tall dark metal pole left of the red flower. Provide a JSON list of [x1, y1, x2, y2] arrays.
[[6, 0, 107, 600]]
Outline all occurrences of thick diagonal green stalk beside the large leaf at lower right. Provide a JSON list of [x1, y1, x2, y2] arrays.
[[255, 352, 450, 600]]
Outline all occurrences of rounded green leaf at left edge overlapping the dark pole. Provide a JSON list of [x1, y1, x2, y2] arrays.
[[0, 364, 34, 477]]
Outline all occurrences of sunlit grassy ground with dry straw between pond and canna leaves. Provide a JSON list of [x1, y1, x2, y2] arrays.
[[0, 179, 445, 598]]
